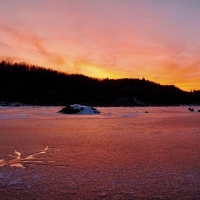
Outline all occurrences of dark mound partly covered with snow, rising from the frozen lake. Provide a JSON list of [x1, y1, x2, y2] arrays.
[[59, 104, 100, 114]]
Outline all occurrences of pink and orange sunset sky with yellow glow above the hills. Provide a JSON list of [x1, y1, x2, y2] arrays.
[[0, 0, 200, 91]]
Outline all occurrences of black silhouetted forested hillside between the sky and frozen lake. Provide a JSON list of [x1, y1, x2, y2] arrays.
[[0, 60, 200, 106]]
